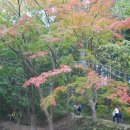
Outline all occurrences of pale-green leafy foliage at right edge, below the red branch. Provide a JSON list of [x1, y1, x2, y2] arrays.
[[97, 40, 130, 75]]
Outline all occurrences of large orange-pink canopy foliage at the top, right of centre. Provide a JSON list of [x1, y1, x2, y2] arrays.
[[60, 0, 114, 34]]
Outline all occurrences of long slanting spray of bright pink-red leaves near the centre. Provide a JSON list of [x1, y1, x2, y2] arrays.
[[23, 65, 71, 87]]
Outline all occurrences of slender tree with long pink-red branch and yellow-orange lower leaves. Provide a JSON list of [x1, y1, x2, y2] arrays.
[[23, 65, 71, 130]]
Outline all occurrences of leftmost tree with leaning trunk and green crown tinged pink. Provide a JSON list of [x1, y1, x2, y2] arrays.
[[1, 15, 49, 130]]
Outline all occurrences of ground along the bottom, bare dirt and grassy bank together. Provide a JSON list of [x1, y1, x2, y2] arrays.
[[0, 114, 130, 130]]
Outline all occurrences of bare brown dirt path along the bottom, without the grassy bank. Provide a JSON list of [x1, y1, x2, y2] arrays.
[[0, 114, 130, 130]]
